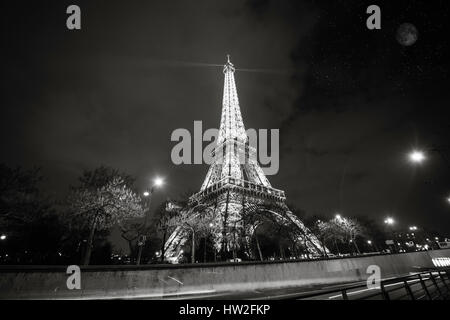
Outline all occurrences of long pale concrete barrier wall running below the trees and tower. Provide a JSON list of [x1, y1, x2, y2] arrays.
[[0, 249, 450, 299]]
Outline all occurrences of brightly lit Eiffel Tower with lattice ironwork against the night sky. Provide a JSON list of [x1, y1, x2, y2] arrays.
[[164, 55, 328, 263]]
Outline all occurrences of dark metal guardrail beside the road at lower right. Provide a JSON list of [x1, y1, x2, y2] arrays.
[[289, 269, 450, 300]]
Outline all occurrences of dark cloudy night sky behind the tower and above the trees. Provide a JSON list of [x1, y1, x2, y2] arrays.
[[0, 0, 450, 250]]
